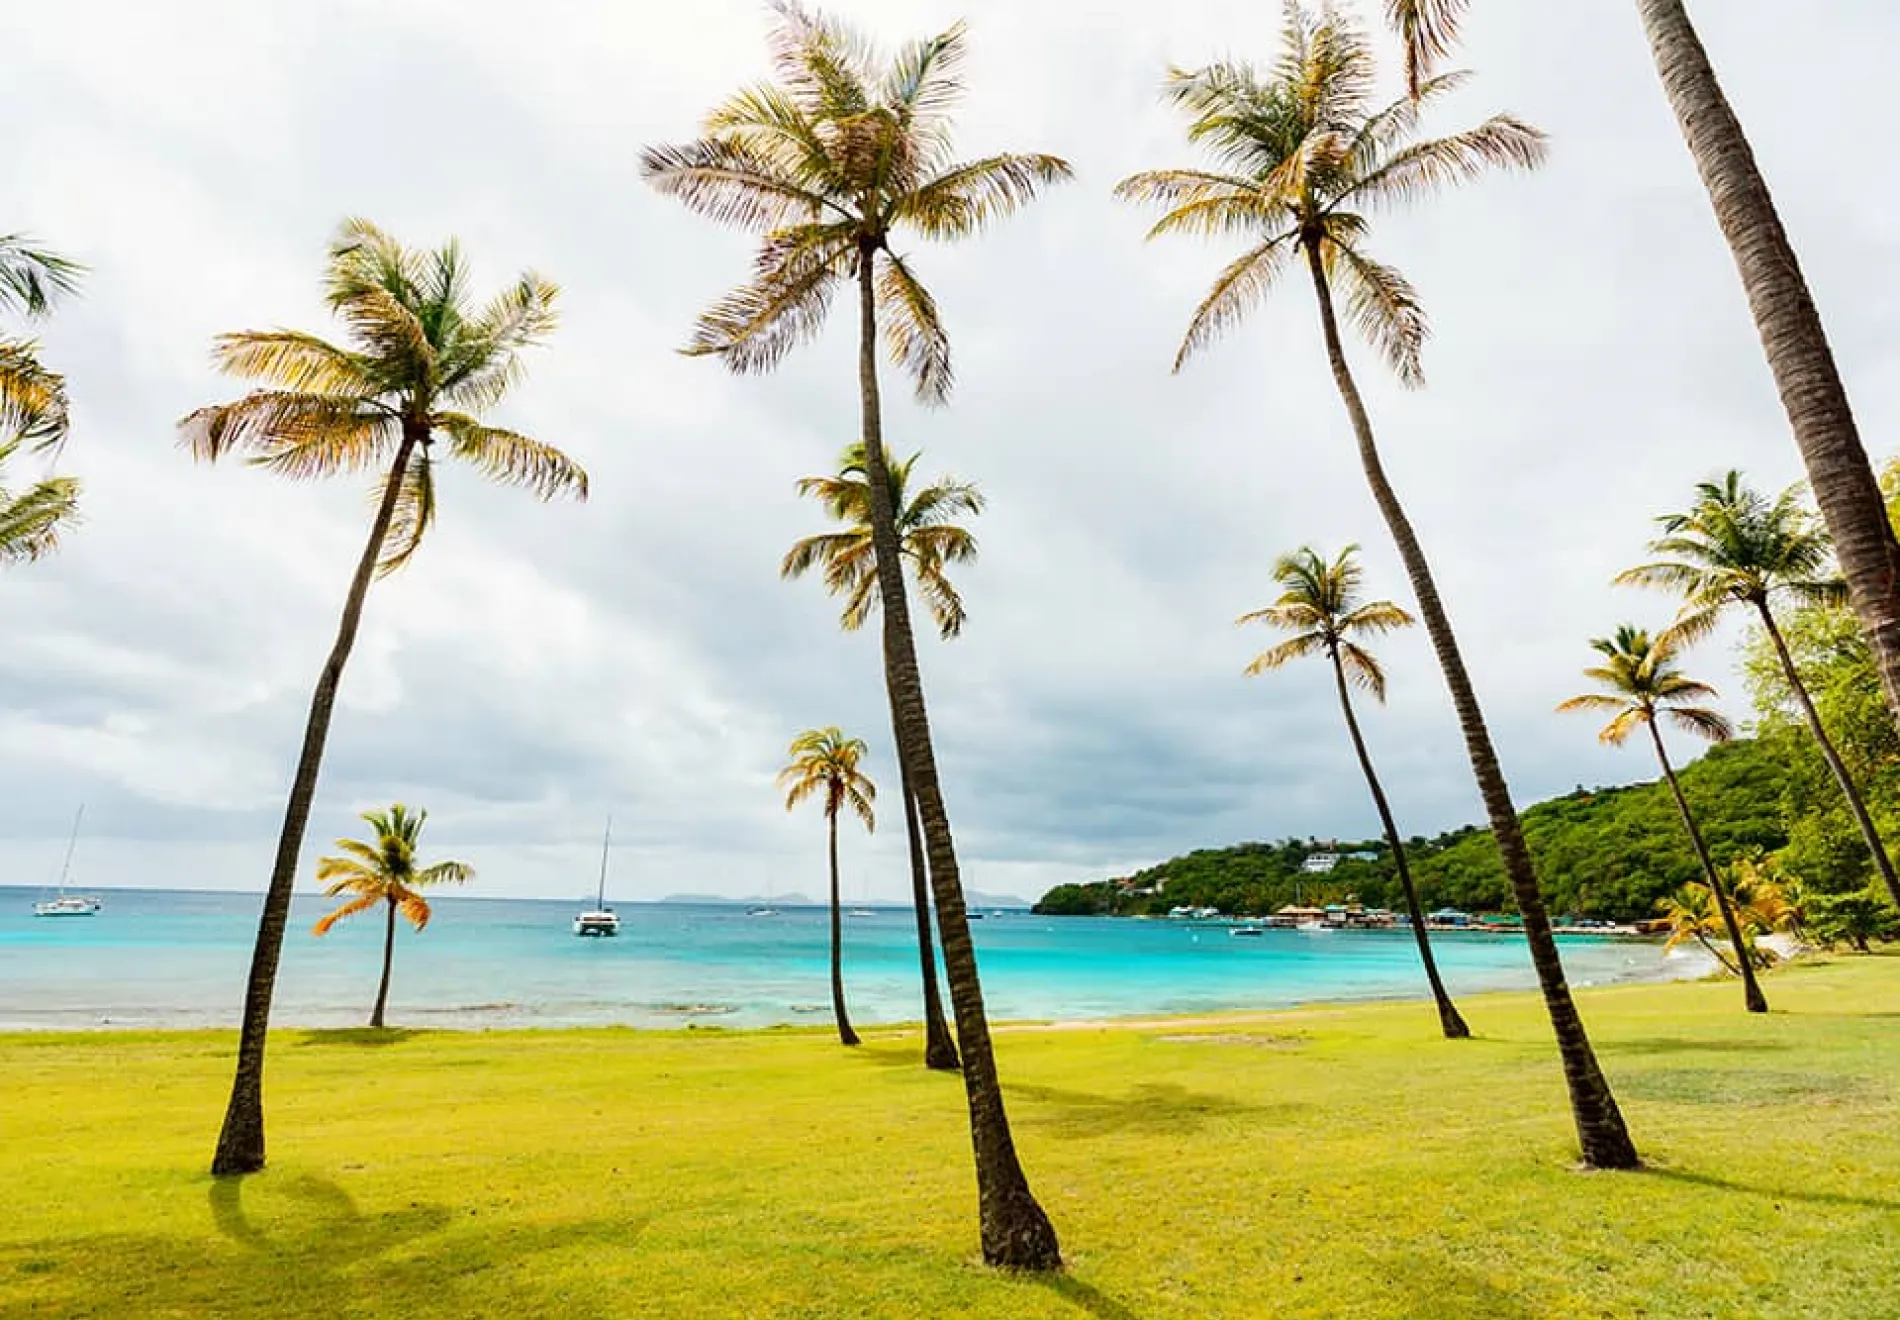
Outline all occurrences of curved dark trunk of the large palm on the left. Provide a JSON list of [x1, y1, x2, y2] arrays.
[[211, 427, 422, 1176]]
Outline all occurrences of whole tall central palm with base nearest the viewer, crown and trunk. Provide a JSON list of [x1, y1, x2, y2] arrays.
[[640, 0, 1070, 1271]]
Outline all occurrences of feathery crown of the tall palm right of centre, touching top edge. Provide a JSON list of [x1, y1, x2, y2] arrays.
[[1115, 0, 1545, 386]]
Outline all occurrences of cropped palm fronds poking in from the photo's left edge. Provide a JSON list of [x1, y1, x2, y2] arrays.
[[0, 234, 82, 564]]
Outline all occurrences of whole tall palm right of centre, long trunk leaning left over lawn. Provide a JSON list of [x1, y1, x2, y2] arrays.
[[1117, 0, 1638, 1168]]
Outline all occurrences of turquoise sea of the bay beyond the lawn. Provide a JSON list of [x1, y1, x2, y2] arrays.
[[0, 887, 1708, 1031]]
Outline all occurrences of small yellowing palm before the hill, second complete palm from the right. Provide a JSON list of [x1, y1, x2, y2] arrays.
[[1558, 625, 1769, 1012]]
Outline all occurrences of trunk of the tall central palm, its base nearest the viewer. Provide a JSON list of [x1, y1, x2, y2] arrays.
[[857, 237, 1062, 1271]]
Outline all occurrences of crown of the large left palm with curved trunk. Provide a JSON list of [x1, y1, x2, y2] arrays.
[[179, 220, 587, 574]]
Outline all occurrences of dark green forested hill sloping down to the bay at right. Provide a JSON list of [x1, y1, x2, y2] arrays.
[[1036, 739, 1788, 919]]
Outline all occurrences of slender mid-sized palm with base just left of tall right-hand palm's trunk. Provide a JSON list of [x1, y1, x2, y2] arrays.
[[1239, 545, 1471, 1041]]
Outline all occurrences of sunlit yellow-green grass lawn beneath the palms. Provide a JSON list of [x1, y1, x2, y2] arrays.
[[0, 957, 1900, 1320]]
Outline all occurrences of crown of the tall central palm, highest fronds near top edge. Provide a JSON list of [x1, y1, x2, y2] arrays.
[[640, 0, 1070, 403]]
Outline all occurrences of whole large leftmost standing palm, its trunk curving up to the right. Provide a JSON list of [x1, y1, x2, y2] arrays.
[[179, 220, 587, 1174]]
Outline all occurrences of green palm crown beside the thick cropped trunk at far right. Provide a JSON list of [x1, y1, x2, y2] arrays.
[[1617, 471, 1847, 636]]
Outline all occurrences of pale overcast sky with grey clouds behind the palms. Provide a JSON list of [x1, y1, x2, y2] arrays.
[[0, 0, 1900, 900]]
